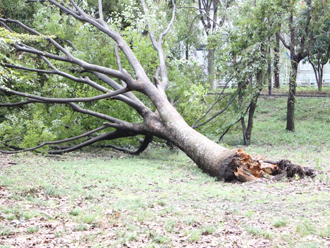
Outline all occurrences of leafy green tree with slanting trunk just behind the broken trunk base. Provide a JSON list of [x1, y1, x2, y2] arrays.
[[193, 1, 277, 145]]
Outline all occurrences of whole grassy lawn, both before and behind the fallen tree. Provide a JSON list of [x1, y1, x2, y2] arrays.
[[0, 96, 330, 247]]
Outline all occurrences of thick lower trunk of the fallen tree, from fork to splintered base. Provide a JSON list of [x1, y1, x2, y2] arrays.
[[144, 98, 314, 182]]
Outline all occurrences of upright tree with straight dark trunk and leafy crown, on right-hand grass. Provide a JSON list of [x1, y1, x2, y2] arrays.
[[279, 0, 326, 132]]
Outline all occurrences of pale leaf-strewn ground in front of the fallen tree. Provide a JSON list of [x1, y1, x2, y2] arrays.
[[0, 150, 330, 247]]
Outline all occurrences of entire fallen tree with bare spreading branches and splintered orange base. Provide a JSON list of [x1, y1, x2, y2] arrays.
[[0, 0, 312, 182]]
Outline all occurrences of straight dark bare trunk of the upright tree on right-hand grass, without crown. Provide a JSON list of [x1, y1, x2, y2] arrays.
[[286, 58, 298, 132]]
